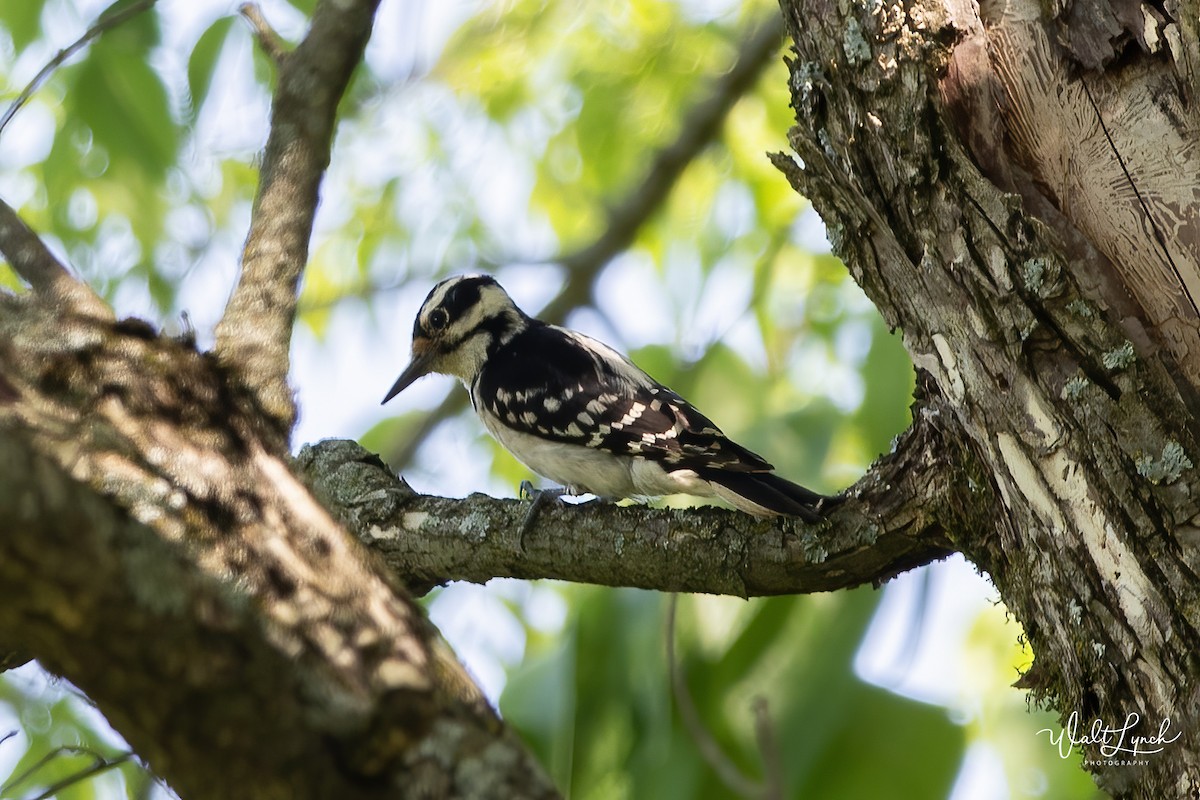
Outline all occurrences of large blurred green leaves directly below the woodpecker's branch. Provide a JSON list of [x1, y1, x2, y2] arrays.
[[502, 589, 965, 800]]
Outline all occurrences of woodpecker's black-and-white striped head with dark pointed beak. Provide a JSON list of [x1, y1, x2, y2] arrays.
[[383, 275, 528, 403]]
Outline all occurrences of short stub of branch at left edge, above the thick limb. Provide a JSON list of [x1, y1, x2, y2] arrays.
[[0, 199, 113, 319]]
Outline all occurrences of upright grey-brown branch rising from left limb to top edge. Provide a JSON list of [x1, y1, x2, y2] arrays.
[[216, 0, 378, 431]]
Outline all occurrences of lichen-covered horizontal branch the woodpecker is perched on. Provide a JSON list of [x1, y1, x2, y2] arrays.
[[299, 398, 966, 597]]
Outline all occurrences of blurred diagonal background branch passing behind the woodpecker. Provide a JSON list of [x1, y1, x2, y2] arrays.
[[386, 13, 784, 469]]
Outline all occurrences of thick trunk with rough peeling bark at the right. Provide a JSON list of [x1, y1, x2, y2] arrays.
[[776, 0, 1200, 798]]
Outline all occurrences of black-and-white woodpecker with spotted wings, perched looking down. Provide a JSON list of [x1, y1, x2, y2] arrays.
[[383, 275, 827, 522]]
